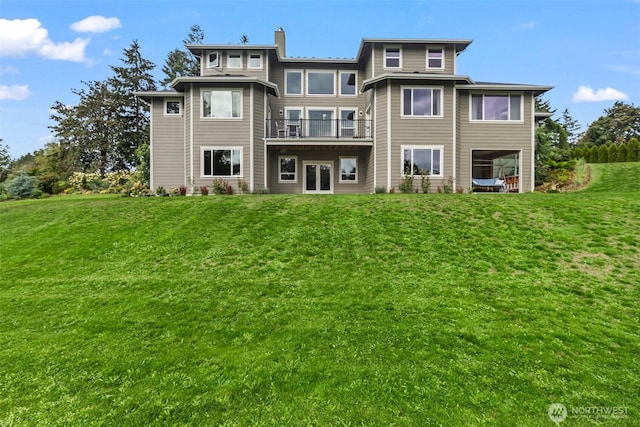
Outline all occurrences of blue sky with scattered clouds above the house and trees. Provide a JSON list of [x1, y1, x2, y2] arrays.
[[0, 0, 640, 158]]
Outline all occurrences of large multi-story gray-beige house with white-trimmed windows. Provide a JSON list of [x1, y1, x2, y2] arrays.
[[137, 28, 552, 193]]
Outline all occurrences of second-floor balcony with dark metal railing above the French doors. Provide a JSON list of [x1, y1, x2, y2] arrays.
[[266, 119, 372, 140]]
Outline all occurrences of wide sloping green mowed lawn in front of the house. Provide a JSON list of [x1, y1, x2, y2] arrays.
[[0, 164, 640, 426]]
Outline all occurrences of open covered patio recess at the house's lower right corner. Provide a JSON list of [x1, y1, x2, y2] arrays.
[[471, 150, 520, 193]]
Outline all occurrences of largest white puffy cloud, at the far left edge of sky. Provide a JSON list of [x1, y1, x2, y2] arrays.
[[0, 19, 90, 62]]
